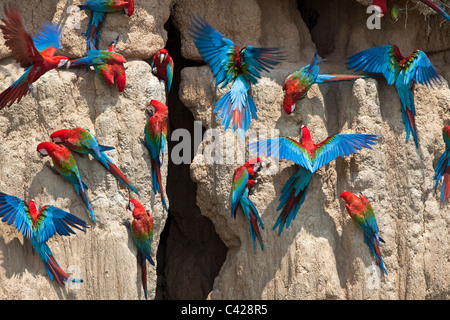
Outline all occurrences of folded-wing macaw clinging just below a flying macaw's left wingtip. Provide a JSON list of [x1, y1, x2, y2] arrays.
[[231, 157, 264, 251]]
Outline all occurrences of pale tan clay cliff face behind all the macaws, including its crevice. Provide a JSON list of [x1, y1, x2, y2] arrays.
[[0, 0, 450, 300]]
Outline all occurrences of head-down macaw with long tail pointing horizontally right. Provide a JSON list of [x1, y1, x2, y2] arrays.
[[283, 52, 366, 114]]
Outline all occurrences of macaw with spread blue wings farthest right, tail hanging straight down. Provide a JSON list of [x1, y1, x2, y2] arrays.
[[347, 45, 440, 148]]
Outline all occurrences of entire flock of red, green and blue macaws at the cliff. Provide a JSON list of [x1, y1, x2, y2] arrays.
[[0, 0, 450, 299]]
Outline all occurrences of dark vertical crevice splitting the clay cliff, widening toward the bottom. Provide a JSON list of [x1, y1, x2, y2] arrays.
[[156, 17, 227, 300]]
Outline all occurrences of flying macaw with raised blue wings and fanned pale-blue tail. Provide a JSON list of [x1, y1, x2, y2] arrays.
[[191, 17, 285, 137]]
